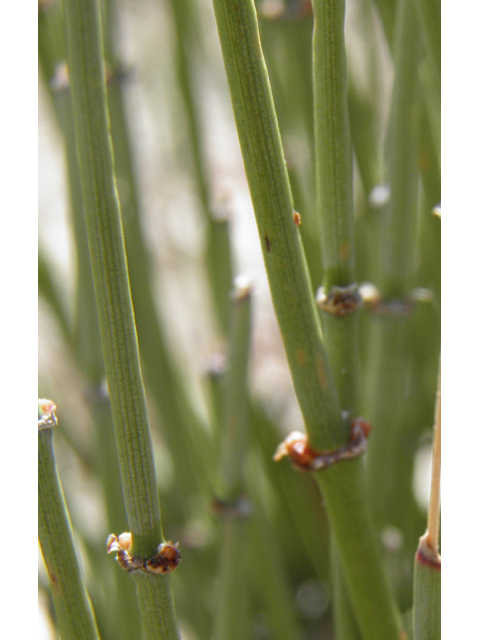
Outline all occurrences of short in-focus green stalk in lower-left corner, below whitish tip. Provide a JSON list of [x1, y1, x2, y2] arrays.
[[38, 429, 100, 640]]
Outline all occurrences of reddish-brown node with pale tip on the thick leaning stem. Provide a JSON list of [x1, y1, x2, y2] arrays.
[[273, 418, 372, 471]]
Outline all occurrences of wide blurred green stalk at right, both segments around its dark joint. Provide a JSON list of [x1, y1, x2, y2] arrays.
[[365, 0, 419, 542]]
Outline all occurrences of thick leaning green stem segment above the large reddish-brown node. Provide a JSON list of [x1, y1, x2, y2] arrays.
[[214, 0, 348, 449]]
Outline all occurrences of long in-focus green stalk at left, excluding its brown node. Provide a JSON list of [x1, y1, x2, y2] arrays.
[[65, 0, 178, 638]]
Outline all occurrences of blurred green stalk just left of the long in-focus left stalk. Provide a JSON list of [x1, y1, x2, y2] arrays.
[[39, 13, 140, 639]]
